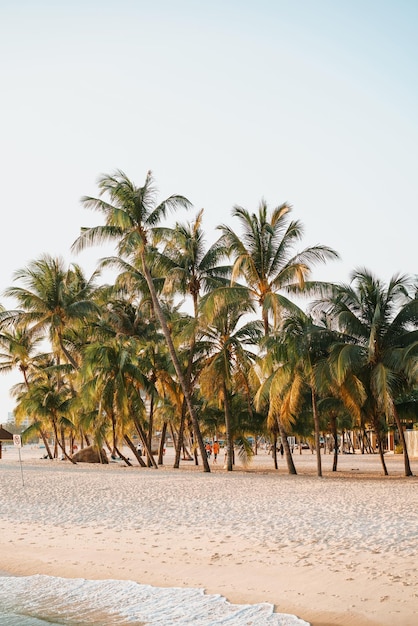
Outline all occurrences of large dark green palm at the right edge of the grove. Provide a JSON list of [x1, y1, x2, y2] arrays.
[[320, 269, 418, 476]]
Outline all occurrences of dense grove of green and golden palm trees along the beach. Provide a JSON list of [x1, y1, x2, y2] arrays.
[[0, 171, 418, 476]]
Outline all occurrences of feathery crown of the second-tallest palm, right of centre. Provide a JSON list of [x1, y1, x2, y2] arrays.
[[218, 200, 338, 335]]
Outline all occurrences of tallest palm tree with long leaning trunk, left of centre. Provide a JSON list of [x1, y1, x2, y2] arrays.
[[73, 170, 210, 472]]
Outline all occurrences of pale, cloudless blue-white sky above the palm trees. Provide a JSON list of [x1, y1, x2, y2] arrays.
[[0, 0, 418, 422]]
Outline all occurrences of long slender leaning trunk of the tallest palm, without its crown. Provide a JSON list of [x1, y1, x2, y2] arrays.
[[141, 248, 210, 472]]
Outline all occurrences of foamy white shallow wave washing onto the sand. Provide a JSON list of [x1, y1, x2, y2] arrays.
[[0, 575, 308, 626]]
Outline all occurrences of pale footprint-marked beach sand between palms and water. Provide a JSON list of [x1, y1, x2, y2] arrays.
[[0, 449, 418, 626]]
